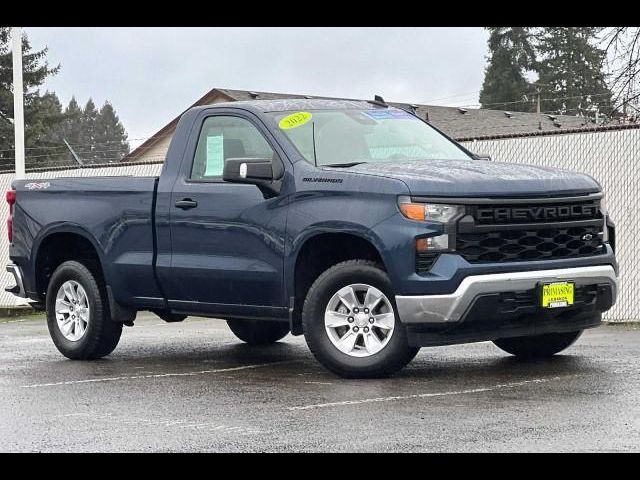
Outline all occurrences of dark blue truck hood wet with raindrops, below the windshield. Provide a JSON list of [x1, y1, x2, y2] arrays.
[[332, 160, 600, 197]]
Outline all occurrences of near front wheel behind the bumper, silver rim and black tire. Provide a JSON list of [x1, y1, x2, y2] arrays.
[[302, 260, 419, 378]]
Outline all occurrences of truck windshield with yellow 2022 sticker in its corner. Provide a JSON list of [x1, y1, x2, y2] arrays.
[[270, 108, 471, 166]]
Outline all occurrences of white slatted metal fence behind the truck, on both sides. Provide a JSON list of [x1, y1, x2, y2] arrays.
[[0, 128, 640, 321]]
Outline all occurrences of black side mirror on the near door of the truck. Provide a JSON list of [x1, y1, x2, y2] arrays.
[[222, 158, 284, 197]]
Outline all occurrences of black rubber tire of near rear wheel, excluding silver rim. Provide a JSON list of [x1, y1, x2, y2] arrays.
[[46, 261, 122, 360]]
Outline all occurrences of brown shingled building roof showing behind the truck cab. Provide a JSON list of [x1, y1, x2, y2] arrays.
[[122, 88, 595, 161]]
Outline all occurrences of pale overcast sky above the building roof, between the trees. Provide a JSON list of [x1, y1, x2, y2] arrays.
[[25, 27, 487, 146]]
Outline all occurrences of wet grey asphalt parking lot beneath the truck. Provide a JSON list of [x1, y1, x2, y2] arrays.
[[0, 314, 640, 452]]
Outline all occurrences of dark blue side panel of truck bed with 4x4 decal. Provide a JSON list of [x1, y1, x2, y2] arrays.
[[11, 176, 160, 299]]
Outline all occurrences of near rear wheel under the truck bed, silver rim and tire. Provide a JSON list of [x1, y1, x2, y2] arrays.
[[46, 261, 122, 360]]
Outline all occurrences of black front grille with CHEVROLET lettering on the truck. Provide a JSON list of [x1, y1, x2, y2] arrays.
[[456, 195, 605, 263]]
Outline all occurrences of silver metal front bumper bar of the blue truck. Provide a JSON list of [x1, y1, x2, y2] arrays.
[[396, 265, 618, 326]]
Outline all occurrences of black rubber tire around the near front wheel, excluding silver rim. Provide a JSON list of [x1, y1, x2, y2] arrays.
[[302, 260, 420, 378]]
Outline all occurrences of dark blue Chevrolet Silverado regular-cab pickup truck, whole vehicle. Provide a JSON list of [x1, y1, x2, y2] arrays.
[[7, 99, 618, 377]]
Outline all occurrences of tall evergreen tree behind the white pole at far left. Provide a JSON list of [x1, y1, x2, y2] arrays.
[[0, 27, 60, 168]]
